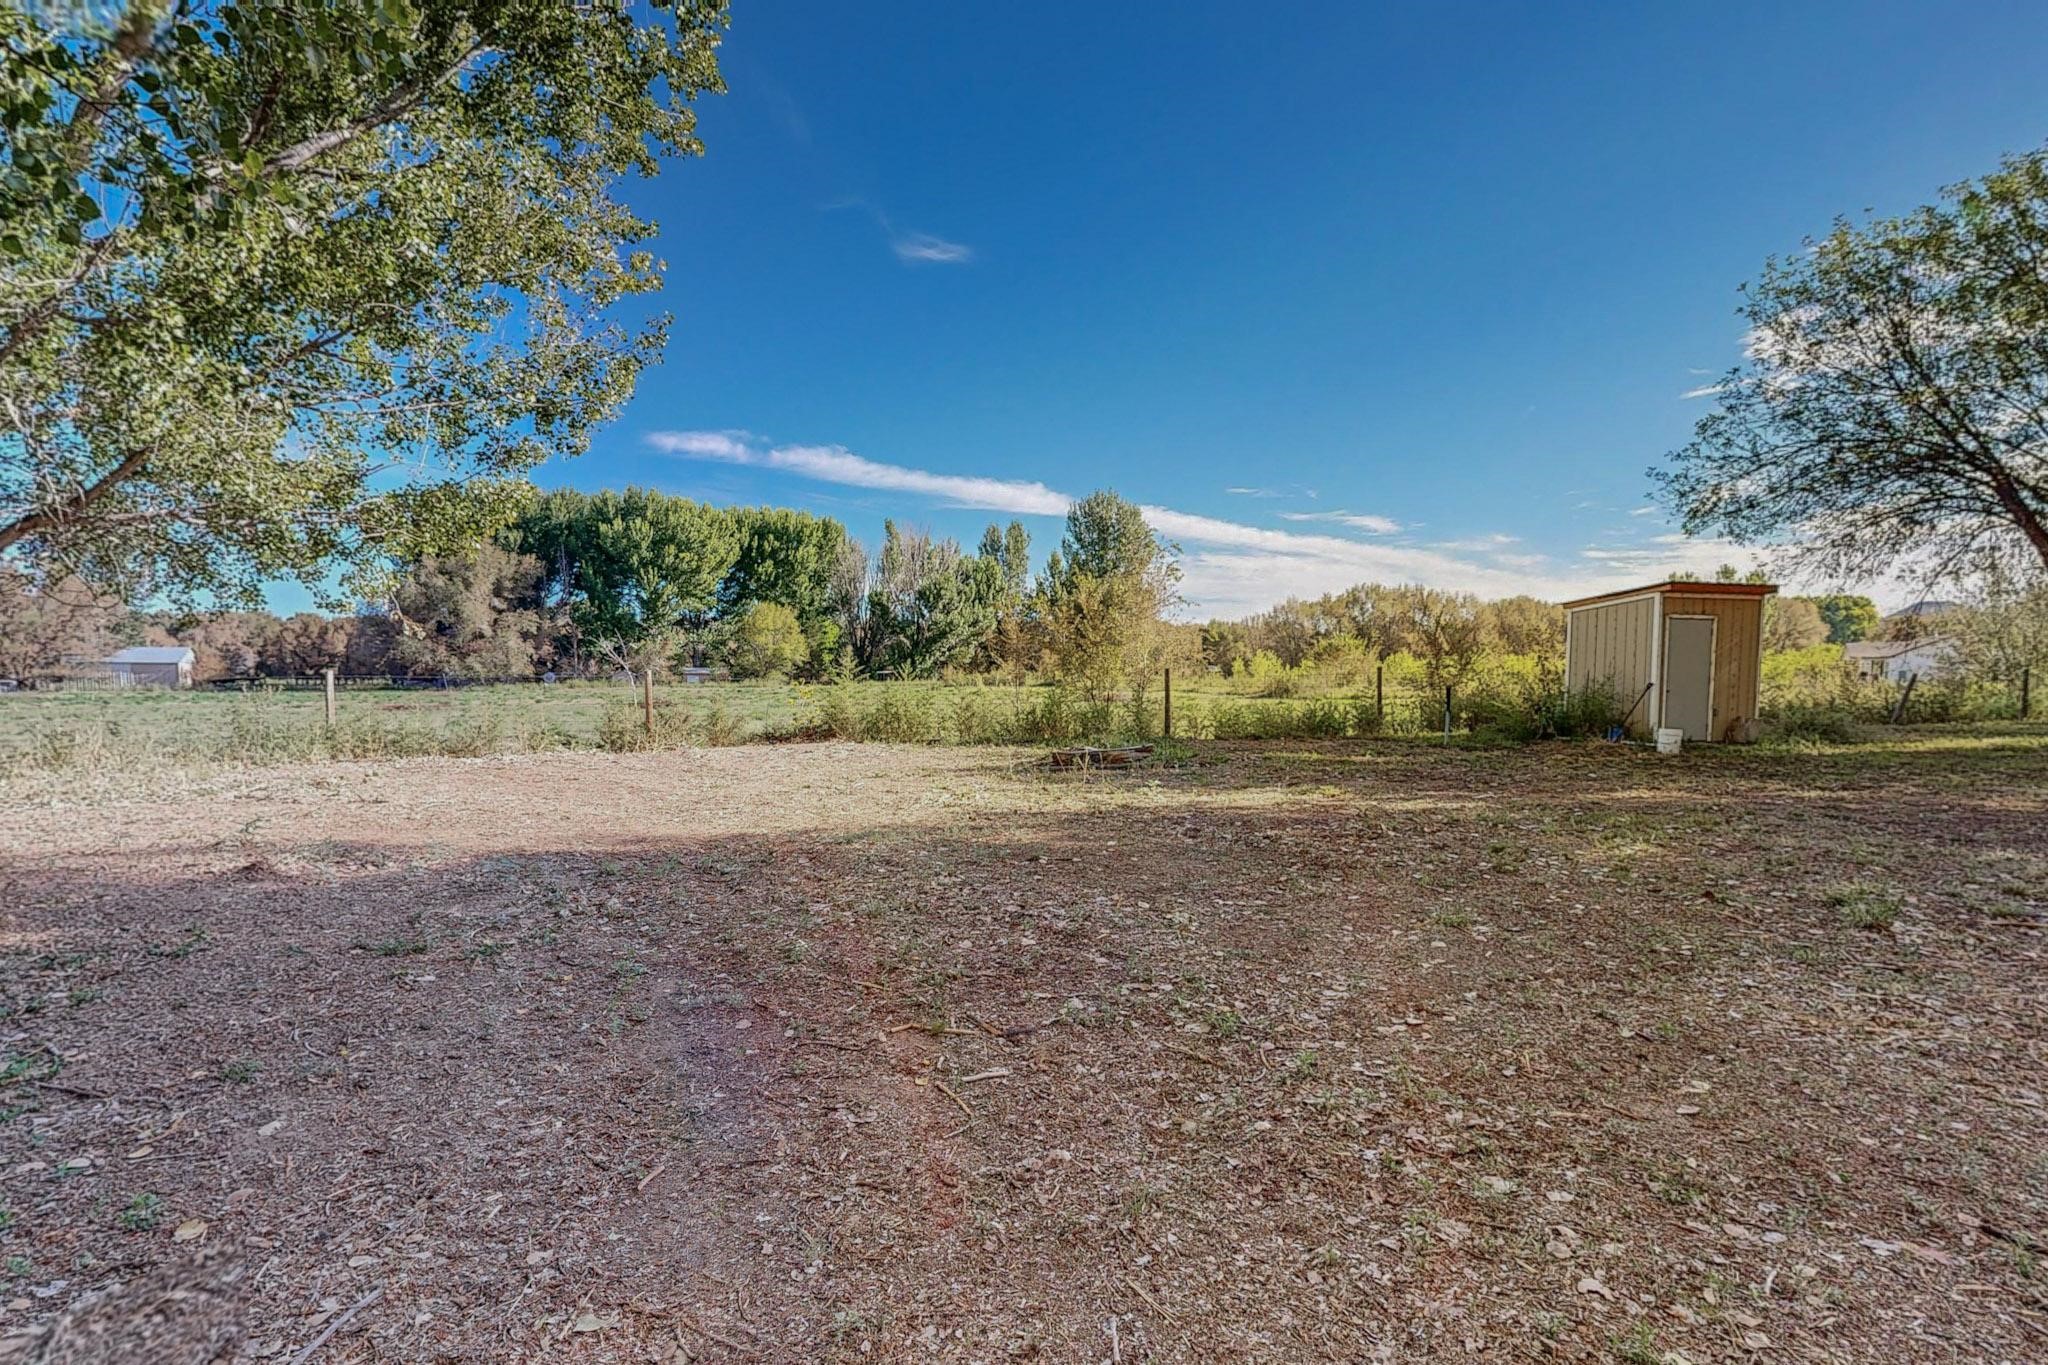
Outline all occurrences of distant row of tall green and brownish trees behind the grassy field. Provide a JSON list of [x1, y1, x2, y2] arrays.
[[0, 487, 1178, 690]]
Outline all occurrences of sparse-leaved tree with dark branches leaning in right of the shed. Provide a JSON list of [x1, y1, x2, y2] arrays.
[[1651, 149, 2048, 579]]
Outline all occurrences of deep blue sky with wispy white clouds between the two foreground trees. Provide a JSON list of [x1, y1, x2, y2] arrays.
[[507, 0, 2048, 614]]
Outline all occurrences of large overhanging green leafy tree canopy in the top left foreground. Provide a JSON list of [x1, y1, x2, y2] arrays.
[[0, 0, 725, 602]]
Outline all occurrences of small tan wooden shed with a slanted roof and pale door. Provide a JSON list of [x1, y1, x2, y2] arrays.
[[1565, 581, 1778, 743]]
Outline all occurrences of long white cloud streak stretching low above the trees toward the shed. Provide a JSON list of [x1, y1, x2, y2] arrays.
[[647, 432, 1777, 616]]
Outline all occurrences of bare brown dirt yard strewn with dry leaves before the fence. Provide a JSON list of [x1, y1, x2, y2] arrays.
[[0, 740, 2048, 1365]]
